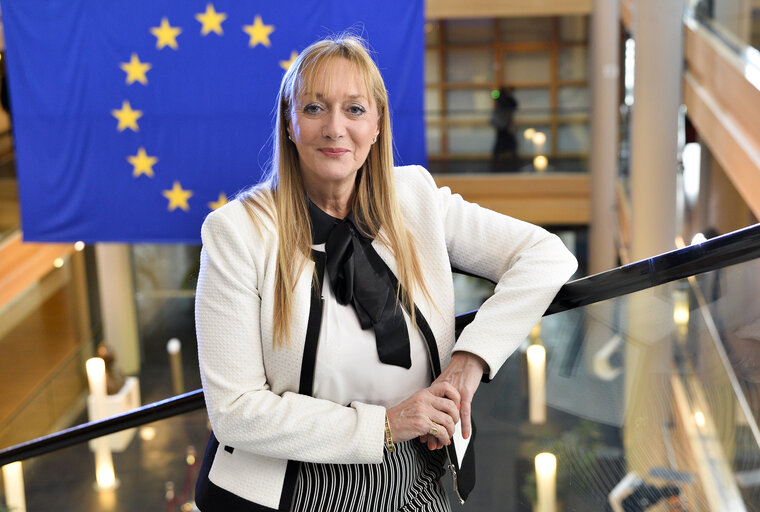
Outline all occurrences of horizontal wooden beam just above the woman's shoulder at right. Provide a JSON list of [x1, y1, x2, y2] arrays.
[[435, 173, 590, 226]]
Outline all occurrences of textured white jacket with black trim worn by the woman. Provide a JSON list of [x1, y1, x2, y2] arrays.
[[196, 166, 576, 511]]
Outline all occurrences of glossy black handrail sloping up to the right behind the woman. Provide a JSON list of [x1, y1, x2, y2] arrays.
[[0, 224, 760, 466]]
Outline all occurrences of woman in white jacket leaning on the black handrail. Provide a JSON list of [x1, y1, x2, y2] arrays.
[[196, 36, 576, 511]]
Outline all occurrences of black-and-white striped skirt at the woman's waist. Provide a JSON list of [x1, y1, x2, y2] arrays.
[[292, 439, 451, 512]]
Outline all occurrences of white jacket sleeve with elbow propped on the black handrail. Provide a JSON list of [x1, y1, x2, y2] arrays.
[[431, 169, 578, 378]]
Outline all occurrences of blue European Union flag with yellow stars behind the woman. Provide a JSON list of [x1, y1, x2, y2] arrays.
[[1, 0, 425, 243]]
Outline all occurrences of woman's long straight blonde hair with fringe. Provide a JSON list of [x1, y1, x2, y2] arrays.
[[241, 34, 430, 345]]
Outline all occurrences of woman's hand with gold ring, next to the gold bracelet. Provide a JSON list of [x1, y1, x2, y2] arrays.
[[387, 382, 460, 446]]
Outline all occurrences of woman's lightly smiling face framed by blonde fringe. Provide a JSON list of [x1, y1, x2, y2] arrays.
[[288, 58, 380, 192]]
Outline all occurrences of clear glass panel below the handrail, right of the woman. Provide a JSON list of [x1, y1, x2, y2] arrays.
[[452, 261, 760, 512]]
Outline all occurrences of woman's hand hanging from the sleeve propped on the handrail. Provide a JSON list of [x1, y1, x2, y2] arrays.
[[420, 352, 487, 450]]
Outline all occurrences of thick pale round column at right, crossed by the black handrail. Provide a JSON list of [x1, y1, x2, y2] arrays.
[[623, 0, 684, 475]]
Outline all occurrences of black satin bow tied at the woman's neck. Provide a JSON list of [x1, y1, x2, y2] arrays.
[[309, 201, 412, 369]]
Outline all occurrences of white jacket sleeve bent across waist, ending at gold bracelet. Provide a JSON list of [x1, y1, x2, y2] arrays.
[[195, 205, 385, 463]]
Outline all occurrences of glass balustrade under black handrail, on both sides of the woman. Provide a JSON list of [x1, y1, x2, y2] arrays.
[[0, 253, 760, 512]]
